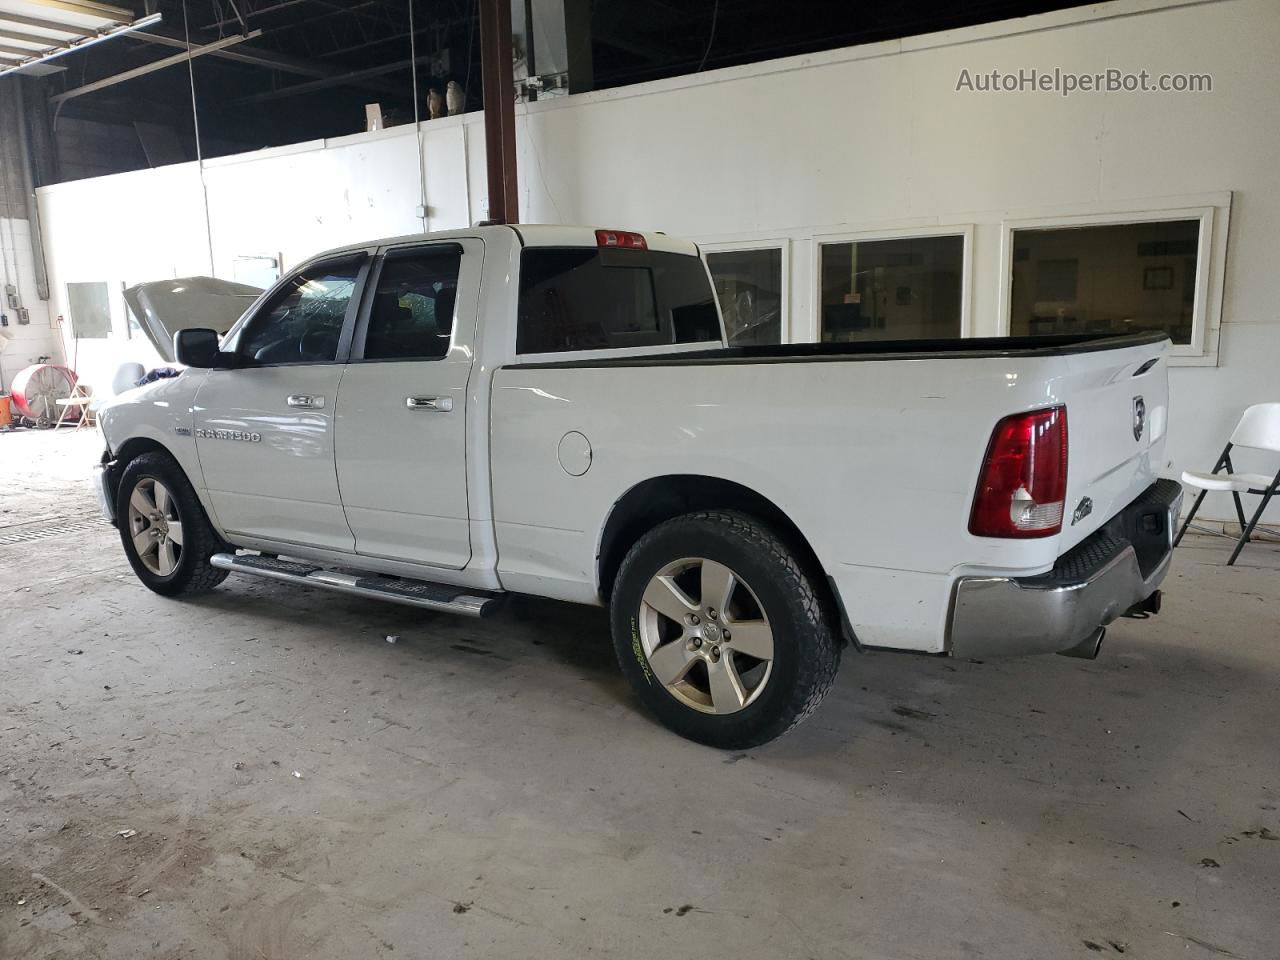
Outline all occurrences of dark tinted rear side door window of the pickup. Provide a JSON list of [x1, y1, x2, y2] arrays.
[[365, 247, 462, 360]]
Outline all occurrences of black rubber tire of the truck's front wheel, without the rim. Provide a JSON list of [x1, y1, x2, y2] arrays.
[[115, 451, 228, 596]]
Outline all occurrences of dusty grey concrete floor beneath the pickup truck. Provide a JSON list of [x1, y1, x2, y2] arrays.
[[0, 433, 1280, 960]]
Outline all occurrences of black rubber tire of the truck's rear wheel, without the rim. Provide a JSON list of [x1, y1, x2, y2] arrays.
[[611, 511, 841, 750]]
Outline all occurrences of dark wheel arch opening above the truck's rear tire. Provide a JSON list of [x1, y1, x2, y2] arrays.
[[596, 474, 852, 640]]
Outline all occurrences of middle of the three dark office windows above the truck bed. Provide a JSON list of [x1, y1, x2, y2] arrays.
[[819, 237, 964, 342]]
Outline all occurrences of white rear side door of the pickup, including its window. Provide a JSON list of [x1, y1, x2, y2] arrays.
[[337, 239, 484, 570]]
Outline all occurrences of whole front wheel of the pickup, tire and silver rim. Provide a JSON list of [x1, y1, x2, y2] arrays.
[[115, 452, 227, 596]]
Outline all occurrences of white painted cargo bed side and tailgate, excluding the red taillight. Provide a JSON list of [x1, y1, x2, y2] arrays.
[[490, 333, 1169, 652]]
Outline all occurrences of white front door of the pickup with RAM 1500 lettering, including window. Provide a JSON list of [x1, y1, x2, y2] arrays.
[[193, 253, 370, 552]]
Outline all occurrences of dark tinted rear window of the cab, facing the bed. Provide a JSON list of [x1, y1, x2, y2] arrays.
[[516, 247, 719, 353]]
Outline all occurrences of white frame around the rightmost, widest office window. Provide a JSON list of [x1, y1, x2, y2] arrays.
[[996, 192, 1231, 366]]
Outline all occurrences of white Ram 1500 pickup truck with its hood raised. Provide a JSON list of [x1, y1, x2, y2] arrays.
[[99, 227, 1181, 749]]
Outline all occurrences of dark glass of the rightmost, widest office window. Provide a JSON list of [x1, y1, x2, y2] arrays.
[[1009, 219, 1201, 343]]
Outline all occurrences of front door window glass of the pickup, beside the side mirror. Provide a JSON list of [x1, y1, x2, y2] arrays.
[[237, 260, 362, 364]]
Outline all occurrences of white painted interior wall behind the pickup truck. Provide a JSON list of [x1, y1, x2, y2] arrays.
[[32, 0, 1280, 517]]
